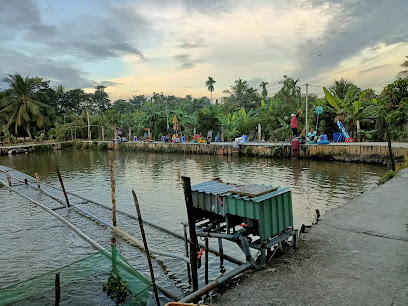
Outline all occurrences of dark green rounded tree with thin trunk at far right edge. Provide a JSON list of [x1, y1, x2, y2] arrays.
[[379, 78, 408, 171]]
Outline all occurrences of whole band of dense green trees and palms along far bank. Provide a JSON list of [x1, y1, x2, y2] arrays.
[[0, 74, 408, 141]]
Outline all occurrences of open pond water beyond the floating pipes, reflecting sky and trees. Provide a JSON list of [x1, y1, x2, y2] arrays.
[[0, 150, 384, 229]]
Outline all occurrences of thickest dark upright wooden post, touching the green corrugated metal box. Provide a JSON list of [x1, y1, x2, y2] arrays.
[[181, 176, 198, 291]]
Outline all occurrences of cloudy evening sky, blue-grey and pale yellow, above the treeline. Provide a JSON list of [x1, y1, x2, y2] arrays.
[[0, 0, 408, 100]]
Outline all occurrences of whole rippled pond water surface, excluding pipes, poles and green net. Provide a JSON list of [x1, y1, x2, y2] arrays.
[[0, 149, 385, 304]]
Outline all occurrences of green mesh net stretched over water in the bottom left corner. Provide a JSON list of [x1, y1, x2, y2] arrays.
[[0, 246, 151, 305]]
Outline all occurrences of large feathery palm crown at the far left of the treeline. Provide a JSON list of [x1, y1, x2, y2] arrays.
[[1, 74, 48, 140]]
